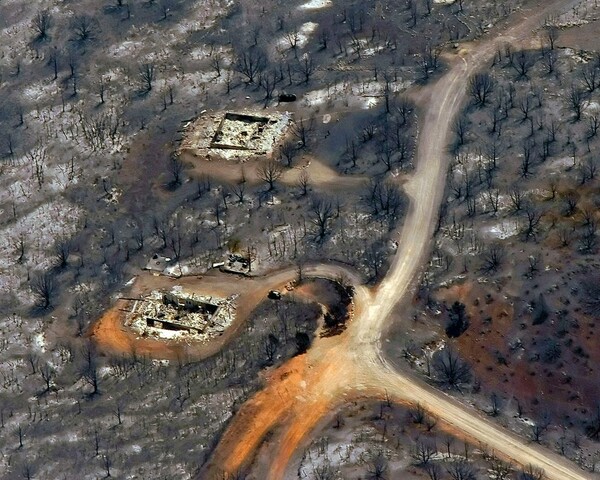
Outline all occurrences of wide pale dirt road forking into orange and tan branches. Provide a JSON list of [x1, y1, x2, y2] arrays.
[[201, 0, 594, 480]]
